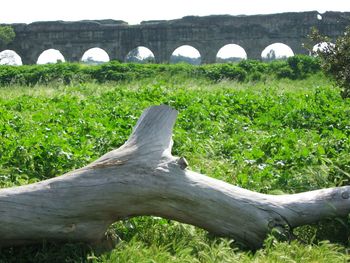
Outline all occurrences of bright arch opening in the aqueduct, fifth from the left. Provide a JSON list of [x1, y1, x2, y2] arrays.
[[170, 45, 202, 65]]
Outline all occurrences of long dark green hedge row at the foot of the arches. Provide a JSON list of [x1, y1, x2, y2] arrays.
[[0, 55, 321, 86]]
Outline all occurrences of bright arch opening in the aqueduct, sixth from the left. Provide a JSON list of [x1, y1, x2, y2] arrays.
[[216, 44, 247, 63]]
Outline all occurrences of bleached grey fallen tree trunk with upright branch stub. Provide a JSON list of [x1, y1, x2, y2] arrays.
[[0, 106, 350, 248]]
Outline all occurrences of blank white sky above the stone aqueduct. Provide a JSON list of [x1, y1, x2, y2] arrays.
[[0, 0, 350, 24]]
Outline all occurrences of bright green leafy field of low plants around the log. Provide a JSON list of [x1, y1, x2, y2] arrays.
[[0, 67, 350, 262]]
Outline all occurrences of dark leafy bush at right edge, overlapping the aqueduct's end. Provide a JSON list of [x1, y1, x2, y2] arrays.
[[306, 26, 350, 98]]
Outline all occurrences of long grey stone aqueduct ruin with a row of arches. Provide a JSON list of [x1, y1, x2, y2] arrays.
[[0, 11, 350, 64]]
